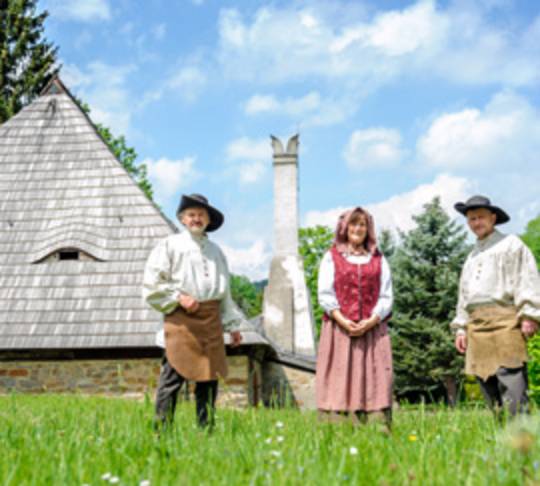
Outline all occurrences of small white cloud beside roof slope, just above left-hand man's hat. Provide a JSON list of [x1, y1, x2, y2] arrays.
[[143, 157, 199, 202]]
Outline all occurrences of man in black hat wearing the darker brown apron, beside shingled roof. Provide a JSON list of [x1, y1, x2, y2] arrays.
[[143, 194, 244, 427]]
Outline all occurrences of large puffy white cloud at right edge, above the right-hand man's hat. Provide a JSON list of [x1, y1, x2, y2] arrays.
[[417, 92, 540, 172]]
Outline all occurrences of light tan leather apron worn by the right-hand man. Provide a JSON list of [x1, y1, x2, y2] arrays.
[[465, 304, 528, 380]]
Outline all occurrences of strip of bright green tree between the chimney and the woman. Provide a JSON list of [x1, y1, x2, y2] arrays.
[[298, 226, 334, 336]]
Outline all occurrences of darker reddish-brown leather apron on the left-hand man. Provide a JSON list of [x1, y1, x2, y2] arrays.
[[164, 300, 227, 381]]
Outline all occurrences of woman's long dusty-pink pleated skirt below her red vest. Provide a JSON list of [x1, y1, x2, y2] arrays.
[[315, 321, 392, 412]]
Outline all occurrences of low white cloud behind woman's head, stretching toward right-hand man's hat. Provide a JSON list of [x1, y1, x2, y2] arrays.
[[304, 174, 476, 231]]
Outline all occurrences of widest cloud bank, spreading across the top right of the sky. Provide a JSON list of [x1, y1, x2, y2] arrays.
[[218, 0, 540, 87]]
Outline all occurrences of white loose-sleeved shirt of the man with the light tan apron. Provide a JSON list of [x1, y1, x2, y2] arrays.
[[450, 231, 540, 332]]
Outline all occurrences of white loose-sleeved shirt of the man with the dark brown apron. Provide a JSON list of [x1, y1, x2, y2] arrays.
[[143, 231, 245, 347]]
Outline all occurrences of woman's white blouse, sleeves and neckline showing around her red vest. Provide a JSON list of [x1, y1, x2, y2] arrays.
[[318, 251, 394, 321]]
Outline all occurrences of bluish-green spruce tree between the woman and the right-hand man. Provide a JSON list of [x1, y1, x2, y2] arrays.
[[391, 198, 470, 403]]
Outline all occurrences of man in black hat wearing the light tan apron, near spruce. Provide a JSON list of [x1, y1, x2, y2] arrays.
[[451, 196, 540, 415]]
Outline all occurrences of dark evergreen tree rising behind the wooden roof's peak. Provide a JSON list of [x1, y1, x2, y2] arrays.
[[0, 0, 59, 123]]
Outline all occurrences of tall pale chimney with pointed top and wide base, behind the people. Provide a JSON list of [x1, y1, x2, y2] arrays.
[[262, 135, 316, 409]]
